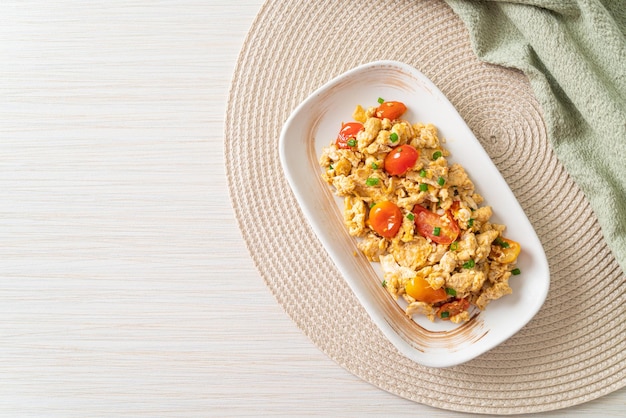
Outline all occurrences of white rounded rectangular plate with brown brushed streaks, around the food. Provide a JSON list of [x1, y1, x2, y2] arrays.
[[279, 61, 550, 367]]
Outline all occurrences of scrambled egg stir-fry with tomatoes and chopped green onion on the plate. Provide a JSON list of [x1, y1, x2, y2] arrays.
[[319, 102, 520, 323]]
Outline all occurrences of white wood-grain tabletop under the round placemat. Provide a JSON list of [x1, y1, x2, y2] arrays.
[[0, 0, 626, 417]]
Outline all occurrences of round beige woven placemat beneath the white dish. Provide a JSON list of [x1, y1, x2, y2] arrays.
[[225, 0, 626, 414]]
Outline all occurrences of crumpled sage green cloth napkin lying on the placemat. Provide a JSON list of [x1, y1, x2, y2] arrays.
[[446, 0, 626, 272]]
